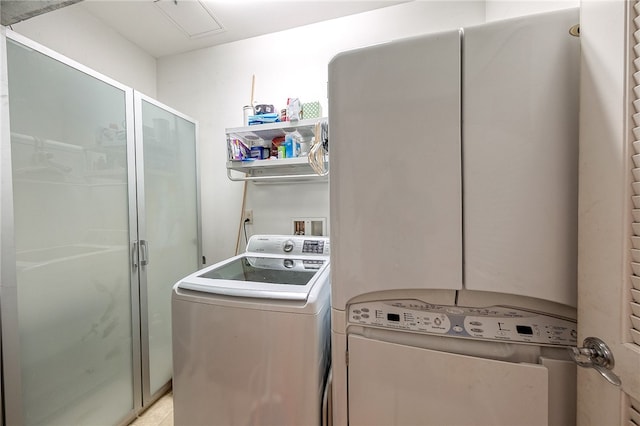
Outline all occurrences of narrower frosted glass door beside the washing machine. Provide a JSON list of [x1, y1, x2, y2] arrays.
[[135, 93, 200, 405]]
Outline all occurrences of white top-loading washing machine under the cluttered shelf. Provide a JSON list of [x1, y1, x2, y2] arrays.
[[172, 235, 330, 426]]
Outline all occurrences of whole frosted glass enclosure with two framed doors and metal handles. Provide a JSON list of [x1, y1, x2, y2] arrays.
[[2, 31, 201, 425]]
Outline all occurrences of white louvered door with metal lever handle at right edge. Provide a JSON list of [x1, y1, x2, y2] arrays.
[[577, 0, 640, 426]]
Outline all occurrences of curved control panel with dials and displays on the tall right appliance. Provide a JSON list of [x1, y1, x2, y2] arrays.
[[347, 300, 578, 346]]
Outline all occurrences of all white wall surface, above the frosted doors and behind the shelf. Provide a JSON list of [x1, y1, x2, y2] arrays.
[[5, 0, 579, 262]]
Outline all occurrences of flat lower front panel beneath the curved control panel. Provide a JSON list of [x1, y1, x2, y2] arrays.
[[349, 335, 548, 426]]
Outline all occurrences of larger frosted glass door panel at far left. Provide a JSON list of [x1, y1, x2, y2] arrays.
[[5, 37, 140, 425]]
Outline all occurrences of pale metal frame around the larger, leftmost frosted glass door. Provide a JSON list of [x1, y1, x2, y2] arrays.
[[0, 27, 142, 424]]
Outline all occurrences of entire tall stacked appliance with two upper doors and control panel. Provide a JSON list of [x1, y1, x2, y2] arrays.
[[329, 9, 579, 425]]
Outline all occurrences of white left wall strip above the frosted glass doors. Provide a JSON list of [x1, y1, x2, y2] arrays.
[[11, 3, 156, 97]]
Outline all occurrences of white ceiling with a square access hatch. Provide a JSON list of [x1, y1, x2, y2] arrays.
[[62, 0, 406, 58]]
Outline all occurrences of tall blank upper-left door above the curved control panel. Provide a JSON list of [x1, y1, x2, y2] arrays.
[[329, 30, 462, 310]]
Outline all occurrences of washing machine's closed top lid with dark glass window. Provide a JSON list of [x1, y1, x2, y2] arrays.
[[178, 255, 328, 300]]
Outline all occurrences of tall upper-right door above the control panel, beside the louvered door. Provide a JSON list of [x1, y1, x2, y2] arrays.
[[462, 9, 580, 306]]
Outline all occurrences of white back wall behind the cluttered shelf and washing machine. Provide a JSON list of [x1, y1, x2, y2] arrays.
[[158, 1, 485, 263]]
